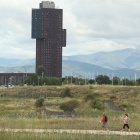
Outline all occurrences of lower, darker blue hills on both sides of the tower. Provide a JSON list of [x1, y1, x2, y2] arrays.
[[0, 60, 140, 79]]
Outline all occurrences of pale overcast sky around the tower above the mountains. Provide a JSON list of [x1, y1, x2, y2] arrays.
[[0, 0, 140, 59]]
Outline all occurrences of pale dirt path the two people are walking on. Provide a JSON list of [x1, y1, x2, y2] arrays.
[[0, 129, 140, 136]]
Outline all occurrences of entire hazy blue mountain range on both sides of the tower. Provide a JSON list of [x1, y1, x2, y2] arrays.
[[0, 49, 140, 79]]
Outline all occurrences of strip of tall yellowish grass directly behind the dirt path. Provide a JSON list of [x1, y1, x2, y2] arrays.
[[0, 116, 140, 131]]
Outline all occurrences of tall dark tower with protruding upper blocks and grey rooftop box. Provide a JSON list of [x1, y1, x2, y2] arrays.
[[32, 1, 66, 78]]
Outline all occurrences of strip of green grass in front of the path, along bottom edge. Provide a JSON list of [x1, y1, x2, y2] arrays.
[[0, 132, 140, 140]]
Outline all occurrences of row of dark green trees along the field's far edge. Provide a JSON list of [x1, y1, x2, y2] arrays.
[[24, 74, 140, 86]]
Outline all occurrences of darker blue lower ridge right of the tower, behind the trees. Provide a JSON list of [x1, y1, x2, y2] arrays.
[[63, 60, 140, 79]]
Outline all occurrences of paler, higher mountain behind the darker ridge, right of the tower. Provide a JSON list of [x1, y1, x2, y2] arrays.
[[63, 49, 140, 69]]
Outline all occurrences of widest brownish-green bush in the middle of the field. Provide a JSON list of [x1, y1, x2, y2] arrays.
[[60, 100, 79, 112]]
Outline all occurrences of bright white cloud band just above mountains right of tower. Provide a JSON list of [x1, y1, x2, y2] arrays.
[[64, 38, 136, 56]]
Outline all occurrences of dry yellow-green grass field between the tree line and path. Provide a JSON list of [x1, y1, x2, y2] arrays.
[[0, 85, 140, 137]]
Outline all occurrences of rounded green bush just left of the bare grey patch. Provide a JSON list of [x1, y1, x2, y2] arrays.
[[91, 100, 104, 110]]
